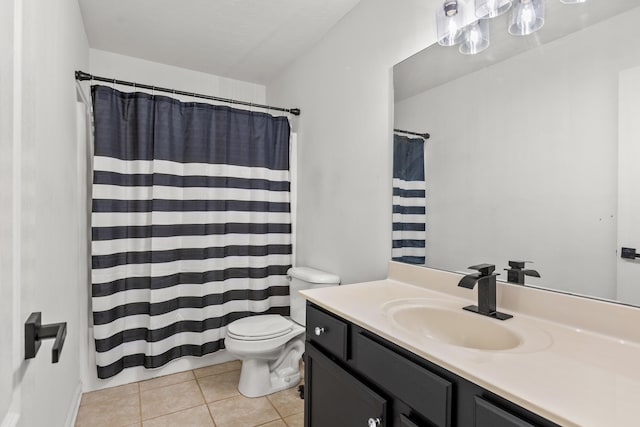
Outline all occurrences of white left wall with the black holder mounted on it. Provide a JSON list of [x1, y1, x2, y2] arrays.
[[13, 0, 89, 427]]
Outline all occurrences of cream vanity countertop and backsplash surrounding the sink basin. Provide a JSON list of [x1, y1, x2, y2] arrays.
[[301, 264, 640, 427]]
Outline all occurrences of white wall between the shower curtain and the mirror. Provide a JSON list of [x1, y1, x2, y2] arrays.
[[267, 0, 438, 283]]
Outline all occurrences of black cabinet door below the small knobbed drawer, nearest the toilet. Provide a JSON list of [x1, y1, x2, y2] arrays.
[[305, 342, 388, 427]]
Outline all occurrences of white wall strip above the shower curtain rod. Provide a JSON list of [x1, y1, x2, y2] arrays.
[[89, 49, 266, 108]]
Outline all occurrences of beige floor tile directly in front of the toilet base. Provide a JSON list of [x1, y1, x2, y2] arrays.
[[209, 396, 280, 427]]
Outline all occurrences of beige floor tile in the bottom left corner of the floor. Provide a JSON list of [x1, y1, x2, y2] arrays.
[[75, 393, 140, 427]]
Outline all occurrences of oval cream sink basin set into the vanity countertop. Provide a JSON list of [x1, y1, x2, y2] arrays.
[[383, 299, 523, 351]]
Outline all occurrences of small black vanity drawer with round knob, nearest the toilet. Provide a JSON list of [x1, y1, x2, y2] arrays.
[[306, 305, 348, 360]]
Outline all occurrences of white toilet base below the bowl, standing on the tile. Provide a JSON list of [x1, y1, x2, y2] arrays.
[[238, 339, 304, 397]]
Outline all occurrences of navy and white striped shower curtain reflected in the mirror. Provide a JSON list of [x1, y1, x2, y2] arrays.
[[391, 135, 426, 264]]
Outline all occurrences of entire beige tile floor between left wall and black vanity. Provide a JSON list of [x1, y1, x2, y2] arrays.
[[76, 361, 304, 427]]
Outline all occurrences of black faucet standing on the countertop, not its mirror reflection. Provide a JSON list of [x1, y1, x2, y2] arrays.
[[458, 264, 513, 320]]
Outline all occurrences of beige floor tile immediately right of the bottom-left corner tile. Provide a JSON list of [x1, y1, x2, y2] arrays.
[[140, 381, 204, 420]]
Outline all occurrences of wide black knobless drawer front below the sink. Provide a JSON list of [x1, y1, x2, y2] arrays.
[[355, 335, 453, 427]]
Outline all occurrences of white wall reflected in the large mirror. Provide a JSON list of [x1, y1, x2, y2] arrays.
[[395, 9, 640, 299]]
